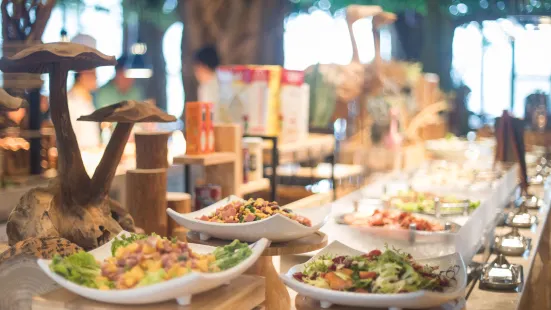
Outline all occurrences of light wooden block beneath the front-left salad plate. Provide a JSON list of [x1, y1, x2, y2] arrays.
[[33, 275, 266, 310]]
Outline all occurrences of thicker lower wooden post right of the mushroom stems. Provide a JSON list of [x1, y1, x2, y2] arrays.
[[126, 169, 168, 236]]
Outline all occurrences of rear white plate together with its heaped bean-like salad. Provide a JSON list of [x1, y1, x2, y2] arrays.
[[167, 196, 331, 242]]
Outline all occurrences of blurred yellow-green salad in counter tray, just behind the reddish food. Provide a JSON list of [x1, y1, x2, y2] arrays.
[[385, 191, 480, 214]]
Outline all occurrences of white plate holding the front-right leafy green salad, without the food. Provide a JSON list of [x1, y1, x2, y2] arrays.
[[279, 241, 467, 309]]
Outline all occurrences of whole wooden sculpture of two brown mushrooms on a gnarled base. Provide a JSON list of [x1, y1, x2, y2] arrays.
[[0, 43, 175, 250]]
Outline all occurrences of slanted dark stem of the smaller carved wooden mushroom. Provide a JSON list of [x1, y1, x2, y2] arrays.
[[90, 123, 134, 202]]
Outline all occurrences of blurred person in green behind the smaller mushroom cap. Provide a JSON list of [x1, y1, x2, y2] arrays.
[[94, 55, 144, 109]]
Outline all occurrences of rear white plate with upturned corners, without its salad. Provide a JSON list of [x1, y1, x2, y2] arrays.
[[166, 196, 331, 242]]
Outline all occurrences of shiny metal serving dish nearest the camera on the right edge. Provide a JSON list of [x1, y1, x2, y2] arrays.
[[480, 254, 523, 290]]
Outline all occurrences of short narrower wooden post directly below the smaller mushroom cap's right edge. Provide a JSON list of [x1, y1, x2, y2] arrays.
[[135, 132, 170, 169]]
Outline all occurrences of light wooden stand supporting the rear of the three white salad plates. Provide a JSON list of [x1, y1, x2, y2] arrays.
[[187, 231, 327, 310]]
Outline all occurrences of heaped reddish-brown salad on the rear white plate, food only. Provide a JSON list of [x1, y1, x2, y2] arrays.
[[198, 198, 312, 227]]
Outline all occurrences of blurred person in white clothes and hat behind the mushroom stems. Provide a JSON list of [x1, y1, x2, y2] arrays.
[[67, 34, 100, 149]]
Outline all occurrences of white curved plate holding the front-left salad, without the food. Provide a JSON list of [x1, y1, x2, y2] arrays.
[[38, 231, 270, 305]]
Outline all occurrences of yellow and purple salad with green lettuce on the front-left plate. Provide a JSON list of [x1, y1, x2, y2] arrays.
[[50, 234, 252, 290]]
